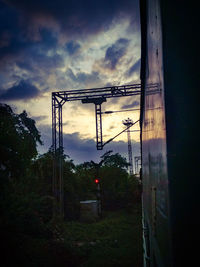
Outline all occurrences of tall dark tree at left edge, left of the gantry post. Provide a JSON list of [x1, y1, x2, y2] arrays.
[[0, 104, 54, 238]]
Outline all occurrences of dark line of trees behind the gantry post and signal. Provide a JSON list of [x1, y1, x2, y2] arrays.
[[0, 104, 140, 260]]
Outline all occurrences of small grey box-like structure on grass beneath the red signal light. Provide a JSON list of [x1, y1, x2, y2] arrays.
[[80, 200, 98, 222]]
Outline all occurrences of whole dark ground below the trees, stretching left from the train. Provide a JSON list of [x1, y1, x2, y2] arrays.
[[1, 204, 142, 267]]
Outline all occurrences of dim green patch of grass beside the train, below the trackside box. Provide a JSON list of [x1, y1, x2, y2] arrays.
[[63, 205, 142, 267]]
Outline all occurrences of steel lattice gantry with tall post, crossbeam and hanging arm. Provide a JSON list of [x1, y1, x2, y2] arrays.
[[52, 84, 141, 216]]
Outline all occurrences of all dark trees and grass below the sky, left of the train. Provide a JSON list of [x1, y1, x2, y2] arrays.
[[0, 104, 141, 266]]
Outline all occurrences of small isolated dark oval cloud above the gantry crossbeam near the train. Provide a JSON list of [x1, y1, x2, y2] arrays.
[[104, 38, 130, 70]]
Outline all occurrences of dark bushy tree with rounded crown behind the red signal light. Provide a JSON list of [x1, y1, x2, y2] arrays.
[[76, 153, 129, 211]]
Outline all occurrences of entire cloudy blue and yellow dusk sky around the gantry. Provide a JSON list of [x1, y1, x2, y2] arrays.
[[0, 0, 140, 168]]
